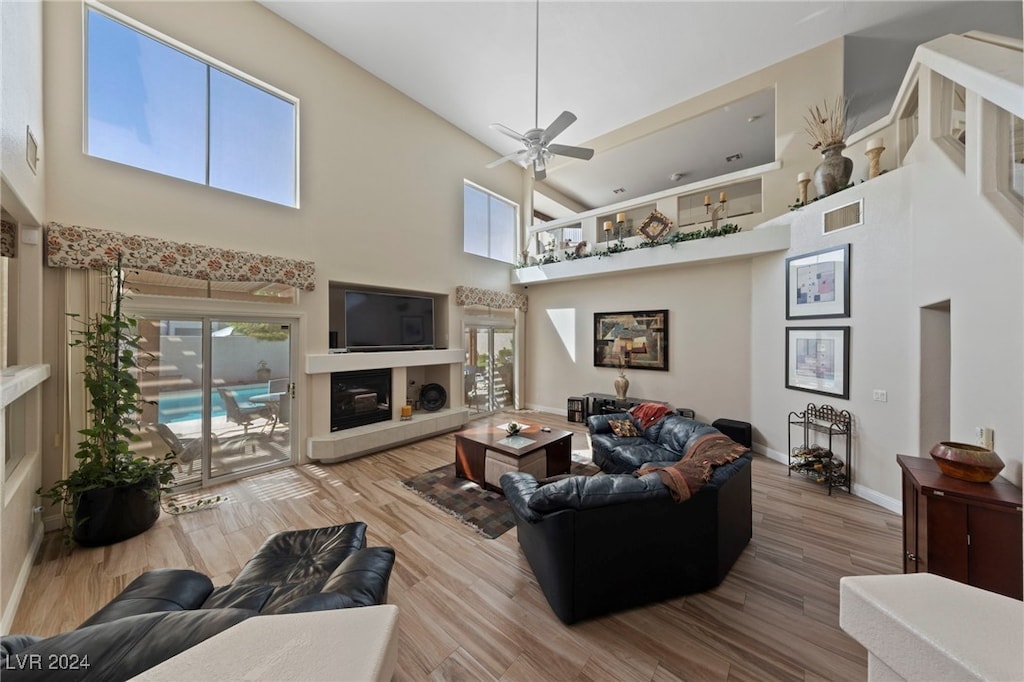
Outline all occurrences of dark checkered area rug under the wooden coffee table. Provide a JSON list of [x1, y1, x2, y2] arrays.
[[401, 454, 600, 540]]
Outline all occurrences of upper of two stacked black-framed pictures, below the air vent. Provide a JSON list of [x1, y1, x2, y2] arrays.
[[785, 244, 850, 319]]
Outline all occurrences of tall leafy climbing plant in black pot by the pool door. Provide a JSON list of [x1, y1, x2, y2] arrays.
[[37, 254, 174, 547]]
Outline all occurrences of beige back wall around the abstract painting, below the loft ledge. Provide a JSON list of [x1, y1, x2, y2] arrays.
[[525, 260, 751, 421]]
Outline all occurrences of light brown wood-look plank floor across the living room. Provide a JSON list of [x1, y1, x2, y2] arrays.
[[11, 405, 901, 682]]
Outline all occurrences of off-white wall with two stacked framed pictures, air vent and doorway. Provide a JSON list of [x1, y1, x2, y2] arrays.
[[751, 141, 1024, 503]]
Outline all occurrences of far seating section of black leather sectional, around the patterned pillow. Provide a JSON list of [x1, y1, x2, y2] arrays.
[[587, 412, 720, 473]]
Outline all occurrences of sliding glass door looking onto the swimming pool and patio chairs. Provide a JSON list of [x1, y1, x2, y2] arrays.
[[132, 314, 294, 485]]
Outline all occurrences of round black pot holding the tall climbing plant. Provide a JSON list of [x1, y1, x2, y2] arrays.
[[72, 478, 160, 547]]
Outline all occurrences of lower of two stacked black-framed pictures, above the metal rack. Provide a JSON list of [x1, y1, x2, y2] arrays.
[[785, 327, 850, 398]]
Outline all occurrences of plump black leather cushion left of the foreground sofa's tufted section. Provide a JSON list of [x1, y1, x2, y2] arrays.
[[79, 568, 213, 628]]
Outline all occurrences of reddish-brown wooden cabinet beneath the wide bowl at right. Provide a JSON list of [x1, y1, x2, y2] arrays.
[[896, 455, 1024, 599]]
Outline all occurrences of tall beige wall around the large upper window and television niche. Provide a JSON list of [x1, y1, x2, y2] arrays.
[[45, 2, 523, 466]]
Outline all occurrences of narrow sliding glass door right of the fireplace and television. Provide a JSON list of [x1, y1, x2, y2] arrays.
[[464, 324, 515, 413]]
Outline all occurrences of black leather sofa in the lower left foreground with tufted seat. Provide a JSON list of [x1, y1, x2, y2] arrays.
[[0, 521, 395, 682]]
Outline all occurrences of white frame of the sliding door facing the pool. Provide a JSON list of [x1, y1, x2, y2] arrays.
[[125, 295, 305, 485]]
